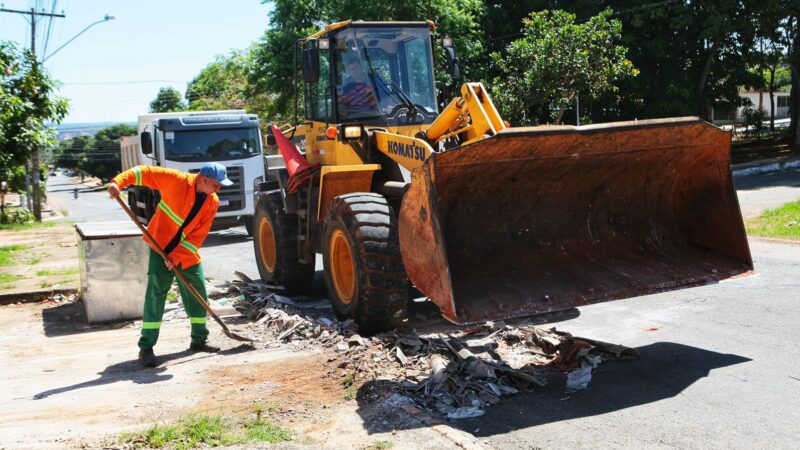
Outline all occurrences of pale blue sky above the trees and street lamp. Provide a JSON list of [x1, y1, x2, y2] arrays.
[[0, 0, 268, 123]]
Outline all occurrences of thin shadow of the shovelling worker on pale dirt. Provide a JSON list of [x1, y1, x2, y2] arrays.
[[33, 345, 254, 400]]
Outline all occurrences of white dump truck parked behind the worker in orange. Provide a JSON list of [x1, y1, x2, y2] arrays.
[[120, 110, 264, 234]]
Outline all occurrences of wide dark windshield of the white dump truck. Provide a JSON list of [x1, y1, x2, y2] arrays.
[[164, 128, 261, 162]]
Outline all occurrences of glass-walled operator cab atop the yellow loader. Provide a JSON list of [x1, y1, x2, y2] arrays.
[[301, 22, 438, 130]]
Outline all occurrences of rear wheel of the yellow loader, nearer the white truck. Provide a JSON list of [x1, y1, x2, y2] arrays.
[[251, 192, 314, 295]]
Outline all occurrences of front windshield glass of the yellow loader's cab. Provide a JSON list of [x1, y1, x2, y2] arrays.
[[334, 27, 437, 122]]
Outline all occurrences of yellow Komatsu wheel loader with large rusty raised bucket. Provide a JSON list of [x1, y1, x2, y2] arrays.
[[253, 21, 753, 333]]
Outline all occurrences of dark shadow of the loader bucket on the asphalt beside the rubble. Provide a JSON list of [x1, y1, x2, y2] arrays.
[[357, 342, 751, 437]]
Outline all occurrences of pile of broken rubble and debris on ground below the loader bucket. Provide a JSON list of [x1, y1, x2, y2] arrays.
[[228, 276, 638, 419]]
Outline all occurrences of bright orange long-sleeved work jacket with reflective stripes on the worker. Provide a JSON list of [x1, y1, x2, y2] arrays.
[[114, 166, 219, 269]]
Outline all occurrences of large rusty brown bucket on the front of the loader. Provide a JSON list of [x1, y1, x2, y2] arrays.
[[399, 117, 753, 323]]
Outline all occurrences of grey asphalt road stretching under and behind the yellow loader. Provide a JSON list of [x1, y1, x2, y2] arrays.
[[50, 170, 800, 449]]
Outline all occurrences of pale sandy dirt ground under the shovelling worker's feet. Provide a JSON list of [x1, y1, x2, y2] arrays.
[[0, 300, 482, 449]]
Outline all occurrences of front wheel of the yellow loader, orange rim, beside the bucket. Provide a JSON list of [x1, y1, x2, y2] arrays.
[[322, 193, 408, 334]]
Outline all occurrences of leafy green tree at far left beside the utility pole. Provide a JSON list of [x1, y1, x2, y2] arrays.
[[0, 41, 68, 220]]
